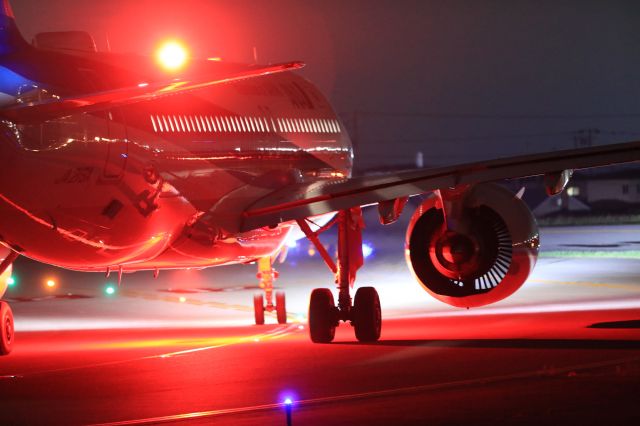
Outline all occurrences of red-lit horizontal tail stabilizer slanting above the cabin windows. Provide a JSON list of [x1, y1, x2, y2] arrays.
[[0, 62, 304, 123]]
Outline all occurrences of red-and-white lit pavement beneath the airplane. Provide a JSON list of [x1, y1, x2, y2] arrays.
[[0, 226, 640, 425]]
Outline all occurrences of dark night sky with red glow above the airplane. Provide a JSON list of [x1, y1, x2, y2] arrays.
[[12, 0, 640, 168]]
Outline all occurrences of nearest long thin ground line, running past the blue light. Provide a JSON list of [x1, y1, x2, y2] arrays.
[[90, 356, 640, 426]]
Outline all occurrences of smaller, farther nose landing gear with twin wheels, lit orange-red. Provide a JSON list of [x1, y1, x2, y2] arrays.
[[253, 257, 287, 325]]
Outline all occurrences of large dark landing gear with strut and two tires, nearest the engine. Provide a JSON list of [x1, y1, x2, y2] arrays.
[[298, 207, 382, 343]]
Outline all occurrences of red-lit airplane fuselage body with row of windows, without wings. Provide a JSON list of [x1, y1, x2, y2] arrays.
[[0, 50, 353, 271]]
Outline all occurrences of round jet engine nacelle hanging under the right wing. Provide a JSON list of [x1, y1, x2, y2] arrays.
[[405, 183, 539, 308]]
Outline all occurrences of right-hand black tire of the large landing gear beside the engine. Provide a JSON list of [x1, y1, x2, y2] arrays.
[[353, 287, 382, 342]]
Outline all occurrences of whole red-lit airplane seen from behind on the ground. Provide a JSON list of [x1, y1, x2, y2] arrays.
[[0, 0, 640, 355]]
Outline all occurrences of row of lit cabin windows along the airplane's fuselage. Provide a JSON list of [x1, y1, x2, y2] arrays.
[[151, 115, 340, 133]]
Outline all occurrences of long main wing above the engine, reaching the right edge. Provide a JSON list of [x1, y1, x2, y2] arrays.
[[239, 141, 640, 231]]
